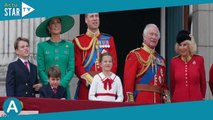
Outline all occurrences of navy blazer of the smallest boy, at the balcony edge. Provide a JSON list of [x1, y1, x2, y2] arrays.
[[39, 83, 67, 99]]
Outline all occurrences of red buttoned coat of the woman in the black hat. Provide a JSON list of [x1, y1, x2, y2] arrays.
[[170, 55, 206, 102]]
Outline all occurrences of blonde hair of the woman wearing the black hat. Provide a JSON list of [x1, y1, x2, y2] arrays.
[[175, 35, 197, 55]]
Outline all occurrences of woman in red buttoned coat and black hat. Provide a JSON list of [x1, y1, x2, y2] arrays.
[[170, 30, 206, 102]]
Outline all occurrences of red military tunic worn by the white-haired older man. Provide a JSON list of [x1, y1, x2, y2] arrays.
[[123, 48, 167, 104]]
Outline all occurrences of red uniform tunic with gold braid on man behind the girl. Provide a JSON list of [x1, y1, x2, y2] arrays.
[[73, 32, 117, 100]]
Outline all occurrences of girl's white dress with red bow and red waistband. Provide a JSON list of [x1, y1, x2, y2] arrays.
[[89, 72, 123, 102]]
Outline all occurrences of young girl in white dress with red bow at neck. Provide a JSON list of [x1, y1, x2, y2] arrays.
[[89, 52, 123, 102]]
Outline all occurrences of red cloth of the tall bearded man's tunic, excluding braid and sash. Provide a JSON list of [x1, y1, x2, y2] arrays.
[[73, 31, 117, 100]]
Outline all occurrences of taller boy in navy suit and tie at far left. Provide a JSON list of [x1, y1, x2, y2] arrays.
[[6, 37, 41, 97]]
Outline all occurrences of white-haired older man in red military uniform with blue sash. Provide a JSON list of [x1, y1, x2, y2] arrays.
[[123, 24, 168, 104]]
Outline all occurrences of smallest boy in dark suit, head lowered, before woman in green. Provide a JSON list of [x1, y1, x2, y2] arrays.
[[39, 66, 67, 99]]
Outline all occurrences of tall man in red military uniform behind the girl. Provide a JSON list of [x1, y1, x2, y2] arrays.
[[73, 13, 117, 100]]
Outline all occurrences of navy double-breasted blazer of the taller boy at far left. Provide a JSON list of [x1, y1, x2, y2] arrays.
[[6, 59, 38, 97]]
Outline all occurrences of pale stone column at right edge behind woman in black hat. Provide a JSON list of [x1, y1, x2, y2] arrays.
[[191, 4, 213, 99]]
